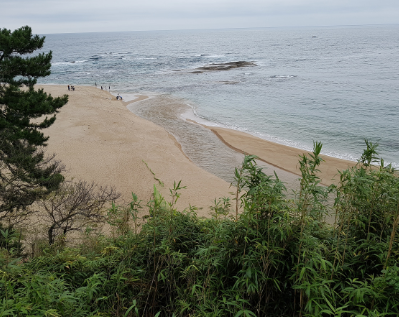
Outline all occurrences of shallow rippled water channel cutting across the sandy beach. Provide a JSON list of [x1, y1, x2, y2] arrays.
[[128, 95, 299, 190]]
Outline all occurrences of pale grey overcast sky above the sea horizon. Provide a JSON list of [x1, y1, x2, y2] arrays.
[[0, 0, 399, 34]]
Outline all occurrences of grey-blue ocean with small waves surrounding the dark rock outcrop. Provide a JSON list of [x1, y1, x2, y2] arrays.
[[40, 25, 399, 168]]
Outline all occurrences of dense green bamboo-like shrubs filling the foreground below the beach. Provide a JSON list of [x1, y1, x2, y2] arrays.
[[0, 144, 399, 317]]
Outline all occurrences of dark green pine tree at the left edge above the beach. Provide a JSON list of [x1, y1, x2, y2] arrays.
[[0, 26, 68, 220]]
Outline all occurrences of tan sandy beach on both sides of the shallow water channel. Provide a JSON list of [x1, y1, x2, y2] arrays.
[[39, 85, 354, 216]]
